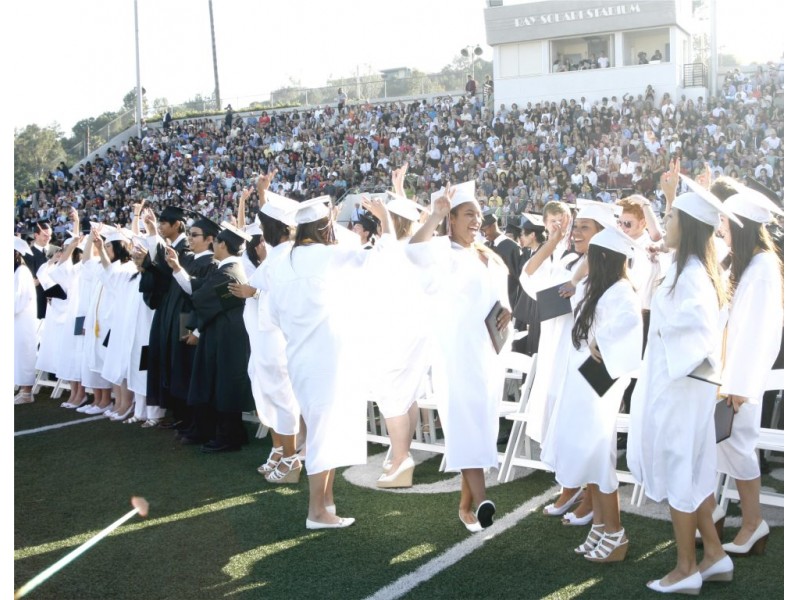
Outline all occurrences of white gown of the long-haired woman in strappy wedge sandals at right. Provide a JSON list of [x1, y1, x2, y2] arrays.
[[541, 279, 642, 494]]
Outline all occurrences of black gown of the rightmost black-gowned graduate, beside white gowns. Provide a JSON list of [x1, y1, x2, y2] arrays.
[[188, 263, 255, 412]]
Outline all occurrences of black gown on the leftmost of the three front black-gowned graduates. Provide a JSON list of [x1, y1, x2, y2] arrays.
[[139, 239, 194, 408]]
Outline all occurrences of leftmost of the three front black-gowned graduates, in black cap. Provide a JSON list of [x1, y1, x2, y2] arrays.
[[139, 206, 194, 427]]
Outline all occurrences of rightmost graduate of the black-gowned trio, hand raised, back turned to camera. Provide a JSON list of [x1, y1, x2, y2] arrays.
[[167, 223, 255, 453]]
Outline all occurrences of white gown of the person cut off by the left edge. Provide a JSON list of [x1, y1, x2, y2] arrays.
[[14, 262, 37, 386]]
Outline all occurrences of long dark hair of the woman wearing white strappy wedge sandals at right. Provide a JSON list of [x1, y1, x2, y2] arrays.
[[572, 245, 628, 350]]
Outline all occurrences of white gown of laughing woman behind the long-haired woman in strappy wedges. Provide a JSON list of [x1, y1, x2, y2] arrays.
[[519, 251, 585, 444]]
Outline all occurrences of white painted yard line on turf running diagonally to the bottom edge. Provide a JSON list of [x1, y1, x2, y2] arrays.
[[367, 486, 561, 600]]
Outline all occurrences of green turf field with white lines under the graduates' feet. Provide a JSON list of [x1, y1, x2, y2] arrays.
[[14, 392, 784, 600]]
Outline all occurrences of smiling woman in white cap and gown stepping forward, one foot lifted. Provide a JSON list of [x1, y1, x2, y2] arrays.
[[407, 181, 511, 532]]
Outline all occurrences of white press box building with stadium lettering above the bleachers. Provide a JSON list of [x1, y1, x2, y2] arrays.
[[484, 0, 708, 110]]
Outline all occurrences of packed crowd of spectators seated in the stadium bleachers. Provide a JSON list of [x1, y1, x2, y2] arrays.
[[16, 62, 784, 236]]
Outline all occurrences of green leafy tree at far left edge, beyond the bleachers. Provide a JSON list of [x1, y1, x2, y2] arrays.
[[14, 123, 66, 192]]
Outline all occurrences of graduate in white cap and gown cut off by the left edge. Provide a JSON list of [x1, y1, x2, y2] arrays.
[[14, 237, 37, 404]]
